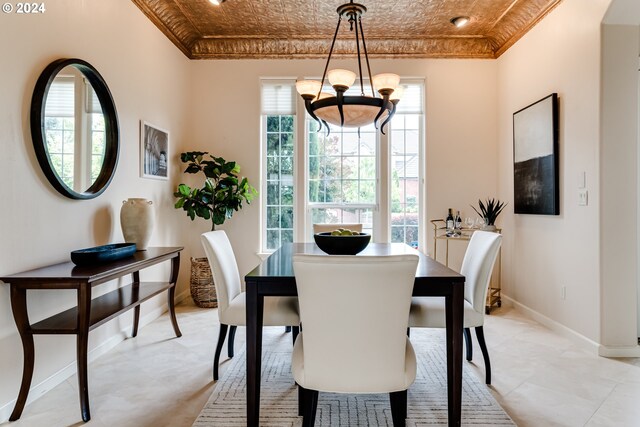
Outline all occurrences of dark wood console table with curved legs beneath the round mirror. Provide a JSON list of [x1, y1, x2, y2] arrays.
[[0, 247, 183, 421]]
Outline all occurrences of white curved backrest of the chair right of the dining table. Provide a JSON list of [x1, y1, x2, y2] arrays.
[[460, 231, 502, 313]]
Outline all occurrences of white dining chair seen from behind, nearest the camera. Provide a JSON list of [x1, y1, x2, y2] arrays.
[[291, 254, 418, 426]]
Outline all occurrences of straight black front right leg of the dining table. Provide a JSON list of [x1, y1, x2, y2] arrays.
[[445, 283, 464, 426]]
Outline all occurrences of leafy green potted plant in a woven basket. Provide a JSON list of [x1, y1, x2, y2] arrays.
[[173, 151, 258, 308]]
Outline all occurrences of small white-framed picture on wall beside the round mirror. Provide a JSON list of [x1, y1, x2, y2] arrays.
[[140, 121, 169, 180]]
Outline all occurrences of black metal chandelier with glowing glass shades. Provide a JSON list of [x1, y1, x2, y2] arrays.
[[296, 0, 403, 134]]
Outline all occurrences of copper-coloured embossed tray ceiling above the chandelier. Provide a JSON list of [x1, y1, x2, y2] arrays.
[[132, 0, 561, 59]]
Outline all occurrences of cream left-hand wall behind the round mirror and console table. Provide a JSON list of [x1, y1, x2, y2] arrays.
[[0, 0, 190, 421]]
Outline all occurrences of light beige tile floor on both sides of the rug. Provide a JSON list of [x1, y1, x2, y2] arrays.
[[3, 304, 640, 427]]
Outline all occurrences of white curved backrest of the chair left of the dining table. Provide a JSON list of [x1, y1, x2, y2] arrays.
[[200, 230, 242, 316]]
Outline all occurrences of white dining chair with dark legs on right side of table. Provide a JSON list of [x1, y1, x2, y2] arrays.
[[409, 231, 502, 384]]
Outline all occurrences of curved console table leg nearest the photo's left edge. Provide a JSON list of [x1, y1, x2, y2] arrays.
[[9, 285, 35, 421]]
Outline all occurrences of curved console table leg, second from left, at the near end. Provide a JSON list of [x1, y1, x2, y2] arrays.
[[76, 283, 91, 422]]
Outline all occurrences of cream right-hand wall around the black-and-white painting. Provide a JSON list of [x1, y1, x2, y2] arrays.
[[497, 0, 609, 342]]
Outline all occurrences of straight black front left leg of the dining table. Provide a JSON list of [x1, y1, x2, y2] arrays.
[[246, 283, 264, 427]]
